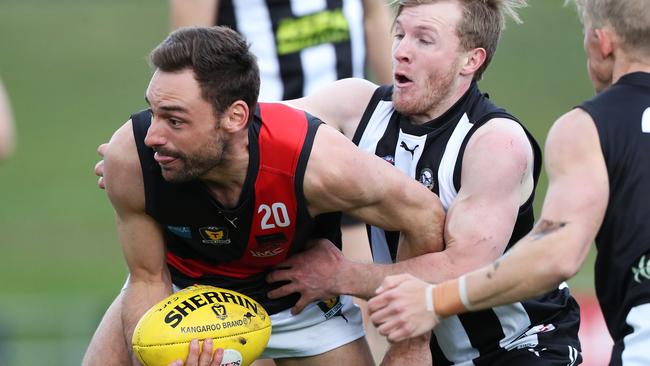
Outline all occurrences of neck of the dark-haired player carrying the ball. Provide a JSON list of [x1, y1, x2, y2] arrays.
[[201, 130, 249, 208]]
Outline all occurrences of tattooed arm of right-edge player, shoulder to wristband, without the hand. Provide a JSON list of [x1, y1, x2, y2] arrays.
[[460, 109, 609, 309]]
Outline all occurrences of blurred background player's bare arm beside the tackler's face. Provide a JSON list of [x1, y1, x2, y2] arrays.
[[363, 0, 393, 85]]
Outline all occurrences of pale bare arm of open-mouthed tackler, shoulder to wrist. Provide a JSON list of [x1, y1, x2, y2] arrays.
[[351, 119, 533, 296]]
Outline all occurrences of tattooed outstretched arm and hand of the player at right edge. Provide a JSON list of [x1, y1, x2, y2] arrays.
[[369, 109, 609, 340]]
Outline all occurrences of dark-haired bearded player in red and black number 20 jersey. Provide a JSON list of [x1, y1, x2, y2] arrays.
[[83, 27, 444, 365]]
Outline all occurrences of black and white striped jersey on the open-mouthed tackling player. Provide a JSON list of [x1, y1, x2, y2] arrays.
[[354, 83, 580, 365]]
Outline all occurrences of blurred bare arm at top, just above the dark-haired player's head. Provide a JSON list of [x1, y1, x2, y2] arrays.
[[169, 0, 219, 29]]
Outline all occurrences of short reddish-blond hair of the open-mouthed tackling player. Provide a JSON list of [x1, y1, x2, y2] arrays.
[[393, 0, 528, 80]]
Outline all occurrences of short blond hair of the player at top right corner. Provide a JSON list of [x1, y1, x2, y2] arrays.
[[574, 0, 650, 56]]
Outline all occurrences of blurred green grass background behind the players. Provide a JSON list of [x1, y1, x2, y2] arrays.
[[0, 0, 593, 366]]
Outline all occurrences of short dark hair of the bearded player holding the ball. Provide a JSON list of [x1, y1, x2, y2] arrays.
[[150, 27, 260, 116]]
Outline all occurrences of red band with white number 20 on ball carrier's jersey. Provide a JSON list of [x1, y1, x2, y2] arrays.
[[167, 103, 308, 278]]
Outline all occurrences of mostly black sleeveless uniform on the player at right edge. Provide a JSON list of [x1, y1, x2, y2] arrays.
[[580, 72, 650, 365]]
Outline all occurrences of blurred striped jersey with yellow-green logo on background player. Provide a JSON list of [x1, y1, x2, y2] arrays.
[[216, 0, 366, 101]]
